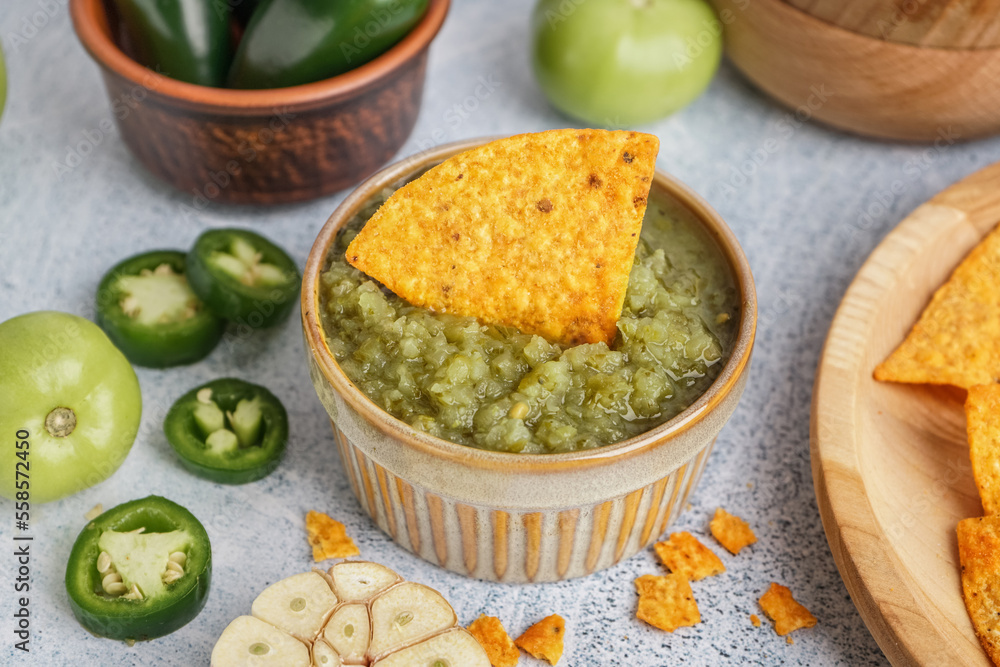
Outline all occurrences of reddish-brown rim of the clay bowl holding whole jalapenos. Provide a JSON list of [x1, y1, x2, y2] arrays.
[[70, 0, 451, 112]]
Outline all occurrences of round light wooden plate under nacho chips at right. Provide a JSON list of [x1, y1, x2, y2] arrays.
[[811, 163, 1000, 667]]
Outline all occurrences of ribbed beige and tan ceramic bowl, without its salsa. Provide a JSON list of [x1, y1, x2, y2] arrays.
[[302, 139, 757, 583]]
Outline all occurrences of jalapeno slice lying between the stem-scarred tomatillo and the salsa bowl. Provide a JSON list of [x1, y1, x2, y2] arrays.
[[163, 378, 288, 484]]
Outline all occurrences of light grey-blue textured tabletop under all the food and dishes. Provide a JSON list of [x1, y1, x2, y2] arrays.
[[0, 0, 1000, 667]]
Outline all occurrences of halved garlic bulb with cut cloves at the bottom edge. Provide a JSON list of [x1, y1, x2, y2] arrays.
[[212, 561, 490, 667]]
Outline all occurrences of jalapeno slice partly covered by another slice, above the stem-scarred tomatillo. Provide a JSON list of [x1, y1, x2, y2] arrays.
[[95, 250, 225, 368]]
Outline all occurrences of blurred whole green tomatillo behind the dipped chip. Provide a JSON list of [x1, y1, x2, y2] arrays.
[[531, 0, 722, 127]]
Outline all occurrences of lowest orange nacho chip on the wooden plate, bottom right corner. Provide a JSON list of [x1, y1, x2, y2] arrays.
[[958, 515, 1000, 665]]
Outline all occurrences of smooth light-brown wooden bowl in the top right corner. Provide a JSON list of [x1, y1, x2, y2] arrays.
[[711, 0, 1000, 142]]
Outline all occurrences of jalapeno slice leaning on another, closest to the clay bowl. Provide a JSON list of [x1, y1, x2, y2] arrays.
[[187, 229, 302, 329]]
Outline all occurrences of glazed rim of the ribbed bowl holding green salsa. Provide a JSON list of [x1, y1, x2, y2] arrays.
[[301, 137, 757, 474]]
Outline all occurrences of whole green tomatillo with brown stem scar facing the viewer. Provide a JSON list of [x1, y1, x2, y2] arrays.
[[0, 311, 142, 503]]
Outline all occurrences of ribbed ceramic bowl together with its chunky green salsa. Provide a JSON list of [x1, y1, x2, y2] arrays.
[[302, 139, 757, 583]]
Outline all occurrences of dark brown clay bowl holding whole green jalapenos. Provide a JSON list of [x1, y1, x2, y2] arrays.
[[76, 0, 449, 209]]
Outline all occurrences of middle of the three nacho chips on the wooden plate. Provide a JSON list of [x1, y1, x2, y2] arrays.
[[965, 384, 1000, 514]]
